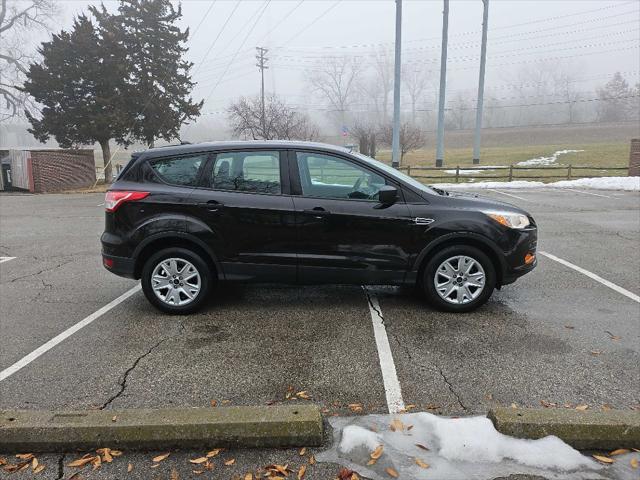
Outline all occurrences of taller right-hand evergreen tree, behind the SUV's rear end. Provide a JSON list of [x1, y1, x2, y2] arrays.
[[91, 0, 203, 146]]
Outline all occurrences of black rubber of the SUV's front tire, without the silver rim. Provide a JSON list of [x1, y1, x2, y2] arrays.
[[421, 245, 496, 313]]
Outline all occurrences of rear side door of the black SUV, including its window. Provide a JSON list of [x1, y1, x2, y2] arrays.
[[188, 150, 296, 283]]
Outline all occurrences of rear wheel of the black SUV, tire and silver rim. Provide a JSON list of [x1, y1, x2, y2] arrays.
[[140, 247, 213, 315]]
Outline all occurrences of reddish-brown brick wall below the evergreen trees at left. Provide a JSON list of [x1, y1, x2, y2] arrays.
[[31, 149, 96, 193]]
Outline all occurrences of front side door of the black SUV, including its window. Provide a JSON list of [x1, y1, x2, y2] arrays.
[[292, 151, 412, 284]]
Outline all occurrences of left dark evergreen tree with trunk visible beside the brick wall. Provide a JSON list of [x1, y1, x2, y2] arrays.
[[23, 15, 129, 182]]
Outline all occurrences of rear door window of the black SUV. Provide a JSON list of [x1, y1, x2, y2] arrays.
[[210, 151, 282, 195]]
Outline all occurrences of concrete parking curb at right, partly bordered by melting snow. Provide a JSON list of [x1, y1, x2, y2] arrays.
[[487, 408, 640, 450]]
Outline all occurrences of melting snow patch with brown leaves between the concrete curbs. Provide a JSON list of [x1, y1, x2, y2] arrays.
[[317, 412, 640, 480]]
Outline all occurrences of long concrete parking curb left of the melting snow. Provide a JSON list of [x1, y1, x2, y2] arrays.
[[0, 405, 323, 452]]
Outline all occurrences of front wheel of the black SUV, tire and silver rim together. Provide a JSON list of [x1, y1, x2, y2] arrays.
[[422, 245, 496, 313]]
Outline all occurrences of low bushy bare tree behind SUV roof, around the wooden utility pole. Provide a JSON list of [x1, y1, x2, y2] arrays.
[[227, 95, 318, 140]]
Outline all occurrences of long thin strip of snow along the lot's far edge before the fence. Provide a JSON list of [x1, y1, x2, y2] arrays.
[[433, 177, 640, 192]]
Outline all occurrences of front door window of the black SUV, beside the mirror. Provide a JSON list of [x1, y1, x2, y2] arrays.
[[296, 152, 385, 201]]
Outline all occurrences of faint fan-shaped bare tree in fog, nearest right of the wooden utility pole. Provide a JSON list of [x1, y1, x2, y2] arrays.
[[307, 56, 361, 125]]
